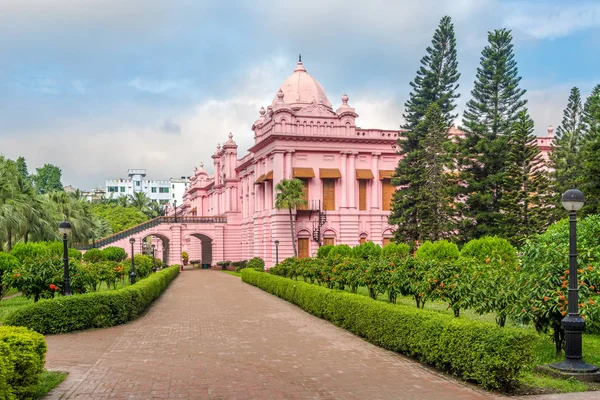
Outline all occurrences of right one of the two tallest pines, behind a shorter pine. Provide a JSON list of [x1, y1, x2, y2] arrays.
[[460, 29, 526, 241]]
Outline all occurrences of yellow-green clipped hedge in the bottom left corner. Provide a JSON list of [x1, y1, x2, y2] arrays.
[[0, 326, 46, 399]]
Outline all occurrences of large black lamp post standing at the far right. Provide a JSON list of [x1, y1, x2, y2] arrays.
[[550, 189, 598, 373]]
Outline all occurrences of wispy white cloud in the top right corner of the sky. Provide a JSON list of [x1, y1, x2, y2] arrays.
[[504, 1, 600, 39]]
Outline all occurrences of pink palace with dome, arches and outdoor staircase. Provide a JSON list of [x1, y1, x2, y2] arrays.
[[96, 61, 553, 267]]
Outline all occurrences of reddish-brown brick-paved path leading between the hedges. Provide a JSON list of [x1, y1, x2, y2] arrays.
[[41, 270, 592, 400]]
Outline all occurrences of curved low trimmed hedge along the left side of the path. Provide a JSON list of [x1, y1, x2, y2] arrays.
[[5, 265, 179, 334]]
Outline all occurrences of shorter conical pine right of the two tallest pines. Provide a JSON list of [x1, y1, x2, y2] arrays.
[[500, 109, 550, 245]]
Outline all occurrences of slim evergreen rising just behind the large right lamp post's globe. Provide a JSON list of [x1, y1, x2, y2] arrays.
[[550, 87, 584, 218]]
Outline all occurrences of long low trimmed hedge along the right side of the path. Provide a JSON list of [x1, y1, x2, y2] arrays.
[[242, 269, 537, 390]]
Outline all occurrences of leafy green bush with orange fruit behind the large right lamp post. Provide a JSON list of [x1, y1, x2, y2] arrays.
[[513, 215, 600, 353]]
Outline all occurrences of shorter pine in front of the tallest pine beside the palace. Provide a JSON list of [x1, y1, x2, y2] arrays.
[[389, 103, 457, 242]]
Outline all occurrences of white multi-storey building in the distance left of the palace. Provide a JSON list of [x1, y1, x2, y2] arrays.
[[105, 169, 190, 204]]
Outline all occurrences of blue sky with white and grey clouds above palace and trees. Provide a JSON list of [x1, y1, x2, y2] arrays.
[[0, 0, 600, 189]]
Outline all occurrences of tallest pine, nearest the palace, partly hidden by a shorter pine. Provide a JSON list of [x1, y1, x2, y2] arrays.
[[389, 16, 460, 241]]
